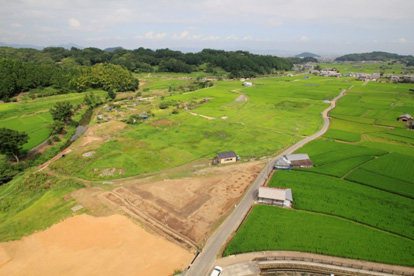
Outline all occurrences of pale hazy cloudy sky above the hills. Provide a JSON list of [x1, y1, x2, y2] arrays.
[[0, 0, 414, 55]]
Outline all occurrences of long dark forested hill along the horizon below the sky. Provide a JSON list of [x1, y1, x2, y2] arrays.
[[0, 47, 292, 77]]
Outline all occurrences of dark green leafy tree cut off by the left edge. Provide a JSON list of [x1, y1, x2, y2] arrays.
[[0, 127, 29, 163]]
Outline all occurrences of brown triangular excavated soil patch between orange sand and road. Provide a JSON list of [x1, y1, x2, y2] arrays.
[[100, 162, 263, 248]]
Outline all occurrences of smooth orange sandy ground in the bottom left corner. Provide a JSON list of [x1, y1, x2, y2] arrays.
[[0, 215, 194, 276]]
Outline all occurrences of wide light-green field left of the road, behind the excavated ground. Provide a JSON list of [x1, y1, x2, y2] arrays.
[[52, 77, 351, 180]]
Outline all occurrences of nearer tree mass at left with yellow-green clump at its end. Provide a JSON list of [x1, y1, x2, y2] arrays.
[[0, 58, 139, 102]]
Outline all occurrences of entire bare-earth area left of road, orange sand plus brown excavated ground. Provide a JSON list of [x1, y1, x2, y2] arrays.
[[0, 156, 264, 276]]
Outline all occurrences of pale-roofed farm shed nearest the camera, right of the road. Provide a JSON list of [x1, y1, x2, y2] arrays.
[[258, 187, 293, 208]]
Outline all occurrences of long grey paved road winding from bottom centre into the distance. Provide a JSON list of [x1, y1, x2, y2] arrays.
[[185, 86, 352, 276]]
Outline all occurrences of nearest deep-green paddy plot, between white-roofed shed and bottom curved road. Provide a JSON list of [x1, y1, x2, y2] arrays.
[[224, 205, 414, 266]]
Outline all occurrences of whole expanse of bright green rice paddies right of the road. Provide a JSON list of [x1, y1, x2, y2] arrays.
[[224, 82, 414, 266]]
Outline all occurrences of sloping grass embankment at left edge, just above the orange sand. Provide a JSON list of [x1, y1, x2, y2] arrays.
[[0, 172, 84, 241]]
